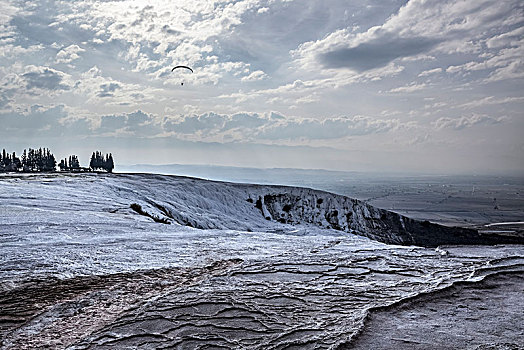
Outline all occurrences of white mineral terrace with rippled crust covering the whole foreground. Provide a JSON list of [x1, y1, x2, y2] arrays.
[[0, 174, 524, 349]]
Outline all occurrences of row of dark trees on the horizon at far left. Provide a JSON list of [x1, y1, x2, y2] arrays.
[[0, 148, 115, 173]]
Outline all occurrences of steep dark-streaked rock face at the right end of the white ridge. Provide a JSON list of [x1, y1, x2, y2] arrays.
[[252, 188, 524, 247]]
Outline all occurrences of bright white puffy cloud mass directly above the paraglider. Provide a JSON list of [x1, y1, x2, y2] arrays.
[[50, 0, 280, 84]]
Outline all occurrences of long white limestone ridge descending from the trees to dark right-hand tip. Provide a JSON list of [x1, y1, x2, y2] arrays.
[[9, 173, 524, 247]]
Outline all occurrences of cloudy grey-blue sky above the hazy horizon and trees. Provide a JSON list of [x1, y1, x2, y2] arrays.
[[0, 0, 524, 175]]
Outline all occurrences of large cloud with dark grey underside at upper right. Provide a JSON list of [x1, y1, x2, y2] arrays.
[[293, 0, 522, 72]]
